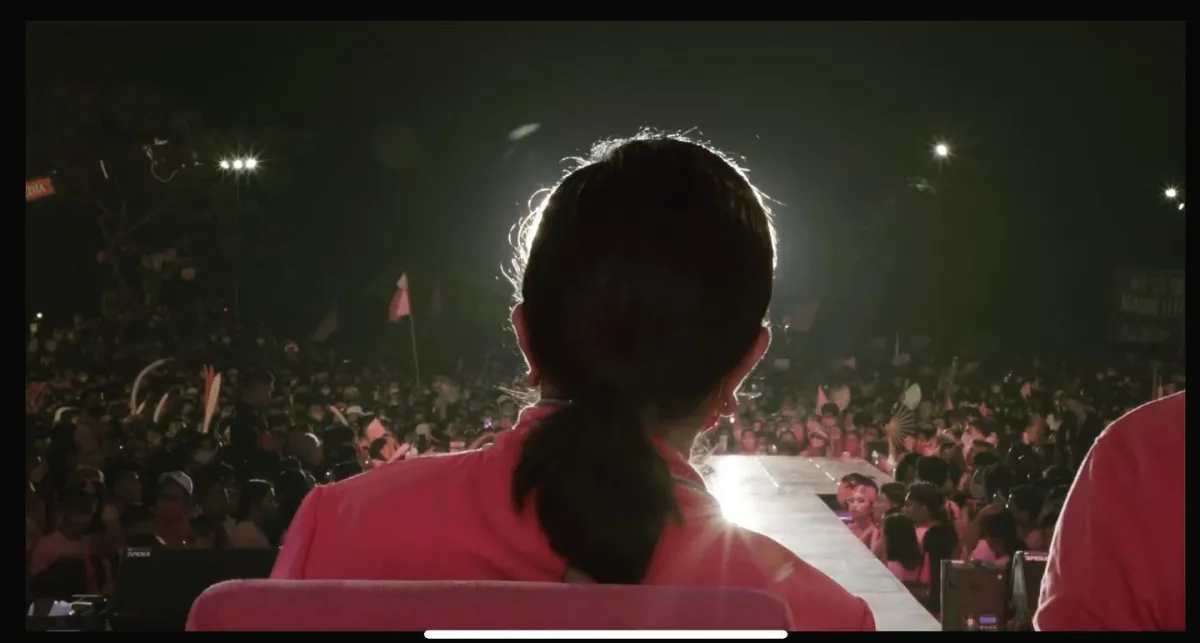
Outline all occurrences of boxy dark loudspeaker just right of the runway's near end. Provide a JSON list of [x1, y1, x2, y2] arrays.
[[942, 560, 1008, 632]]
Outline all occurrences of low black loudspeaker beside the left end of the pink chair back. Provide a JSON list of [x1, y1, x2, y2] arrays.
[[108, 547, 280, 631]]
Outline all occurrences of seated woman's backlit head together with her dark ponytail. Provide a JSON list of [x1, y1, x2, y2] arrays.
[[512, 134, 775, 583]]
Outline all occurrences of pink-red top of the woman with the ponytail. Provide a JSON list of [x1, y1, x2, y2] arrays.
[[271, 407, 875, 631]]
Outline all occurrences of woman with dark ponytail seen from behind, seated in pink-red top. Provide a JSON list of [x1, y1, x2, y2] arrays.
[[272, 134, 875, 630]]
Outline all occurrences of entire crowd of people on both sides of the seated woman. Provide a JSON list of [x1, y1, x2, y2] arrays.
[[25, 312, 1184, 613]]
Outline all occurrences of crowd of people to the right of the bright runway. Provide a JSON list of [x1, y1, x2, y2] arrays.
[[713, 355, 1186, 615]]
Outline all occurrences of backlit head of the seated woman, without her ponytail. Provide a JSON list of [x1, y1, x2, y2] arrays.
[[514, 134, 775, 439]]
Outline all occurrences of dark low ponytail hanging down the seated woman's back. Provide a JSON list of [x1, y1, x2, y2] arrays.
[[512, 401, 679, 584]]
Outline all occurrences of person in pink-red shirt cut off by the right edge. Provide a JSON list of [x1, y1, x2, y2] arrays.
[[1033, 392, 1187, 631]]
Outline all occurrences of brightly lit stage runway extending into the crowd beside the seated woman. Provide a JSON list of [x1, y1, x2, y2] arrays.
[[706, 456, 941, 631]]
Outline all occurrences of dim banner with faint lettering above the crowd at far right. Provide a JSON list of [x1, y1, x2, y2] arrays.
[[1114, 269, 1187, 344]]
